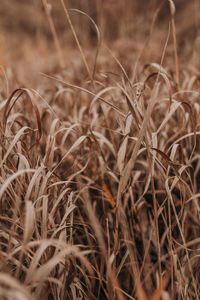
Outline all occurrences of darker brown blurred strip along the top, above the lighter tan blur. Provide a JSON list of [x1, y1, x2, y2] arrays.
[[0, 0, 200, 40]]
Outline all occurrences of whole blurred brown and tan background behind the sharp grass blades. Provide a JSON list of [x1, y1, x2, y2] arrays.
[[0, 0, 200, 84]]
